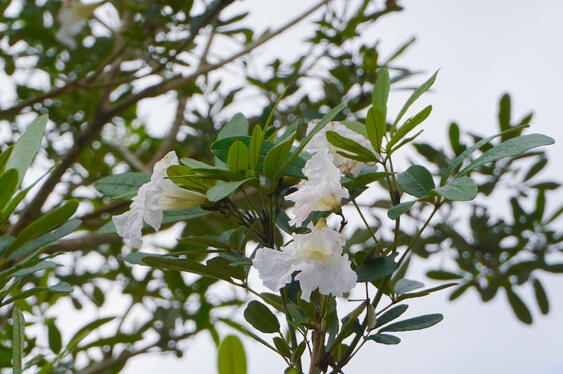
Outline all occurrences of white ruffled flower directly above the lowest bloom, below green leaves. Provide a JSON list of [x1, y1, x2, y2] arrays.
[[285, 149, 348, 226]]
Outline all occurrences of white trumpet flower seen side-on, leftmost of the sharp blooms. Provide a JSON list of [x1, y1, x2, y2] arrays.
[[113, 152, 207, 248]]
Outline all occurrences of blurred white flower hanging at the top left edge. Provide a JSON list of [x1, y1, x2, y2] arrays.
[[55, 0, 100, 48]]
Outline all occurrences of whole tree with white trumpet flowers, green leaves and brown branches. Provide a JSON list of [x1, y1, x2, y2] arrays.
[[0, 0, 563, 374]]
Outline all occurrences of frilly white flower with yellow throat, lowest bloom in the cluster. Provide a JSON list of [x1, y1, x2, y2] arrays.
[[253, 225, 357, 300]]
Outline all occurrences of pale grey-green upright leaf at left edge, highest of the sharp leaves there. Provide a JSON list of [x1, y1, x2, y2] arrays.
[[5, 114, 49, 186]]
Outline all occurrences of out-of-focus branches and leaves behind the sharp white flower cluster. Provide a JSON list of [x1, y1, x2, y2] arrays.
[[0, 0, 563, 373]]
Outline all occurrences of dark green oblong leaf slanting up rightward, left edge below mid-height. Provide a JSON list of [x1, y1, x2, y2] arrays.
[[6, 200, 78, 255]]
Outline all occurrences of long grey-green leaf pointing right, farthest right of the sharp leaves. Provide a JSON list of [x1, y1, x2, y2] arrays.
[[459, 134, 555, 176]]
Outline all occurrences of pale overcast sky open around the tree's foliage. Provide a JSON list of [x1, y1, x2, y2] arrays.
[[124, 0, 563, 374]]
